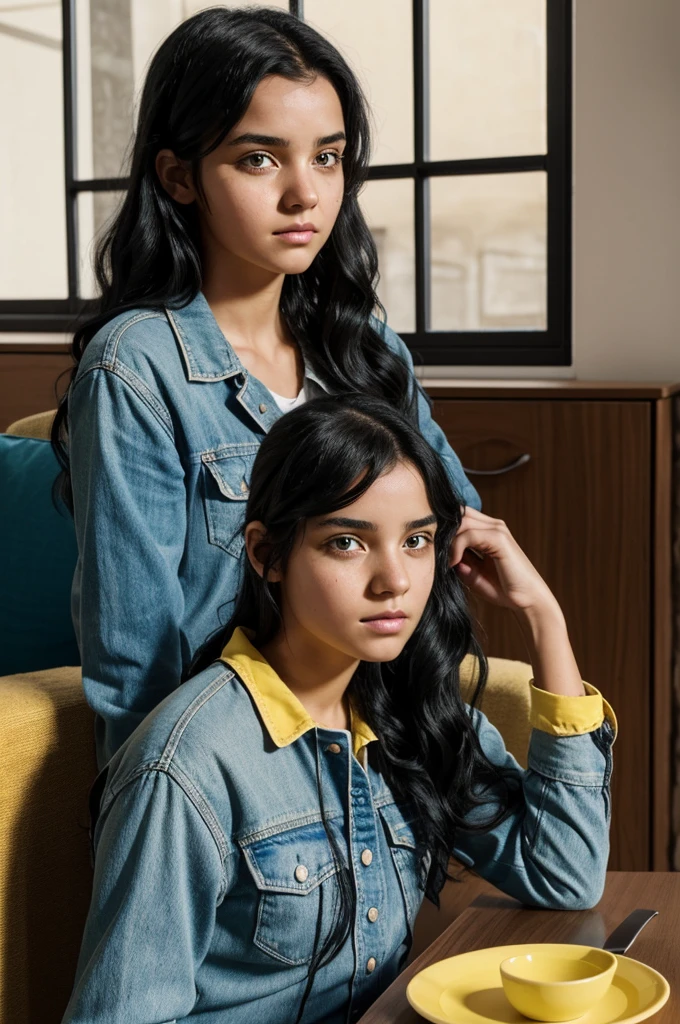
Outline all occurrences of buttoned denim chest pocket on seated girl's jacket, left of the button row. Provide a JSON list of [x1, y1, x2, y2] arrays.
[[241, 821, 337, 966]]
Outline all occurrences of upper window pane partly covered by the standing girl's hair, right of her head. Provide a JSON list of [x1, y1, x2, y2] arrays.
[[304, 0, 413, 164]]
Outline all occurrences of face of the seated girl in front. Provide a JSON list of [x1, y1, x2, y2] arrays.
[[253, 463, 436, 664]]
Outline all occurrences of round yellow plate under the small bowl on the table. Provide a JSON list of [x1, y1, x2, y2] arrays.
[[407, 943, 671, 1024]]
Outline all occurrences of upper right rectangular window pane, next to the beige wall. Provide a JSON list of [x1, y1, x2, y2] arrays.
[[430, 0, 548, 160]]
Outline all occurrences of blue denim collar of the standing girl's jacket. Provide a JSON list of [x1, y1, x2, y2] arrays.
[[165, 292, 328, 391]]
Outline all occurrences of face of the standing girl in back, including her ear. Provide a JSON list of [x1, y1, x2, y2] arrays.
[[157, 76, 345, 274]]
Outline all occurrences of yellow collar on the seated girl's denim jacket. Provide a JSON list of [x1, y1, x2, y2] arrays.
[[220, 628, 378, 756]]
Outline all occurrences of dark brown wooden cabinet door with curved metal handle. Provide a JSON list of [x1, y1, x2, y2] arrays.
[[434, 399, 652, 870]]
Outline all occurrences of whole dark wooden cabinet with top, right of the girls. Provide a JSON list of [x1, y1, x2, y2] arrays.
[[427, 381, 680, 870]]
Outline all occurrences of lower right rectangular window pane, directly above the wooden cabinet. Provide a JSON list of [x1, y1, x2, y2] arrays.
[[430, 171, 547, 331]]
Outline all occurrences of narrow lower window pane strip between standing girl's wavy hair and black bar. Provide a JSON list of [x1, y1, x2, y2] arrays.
[[362, 178, 416, 331]]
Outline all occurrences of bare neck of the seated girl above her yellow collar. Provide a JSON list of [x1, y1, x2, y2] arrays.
[[260, 630, 358, 729]]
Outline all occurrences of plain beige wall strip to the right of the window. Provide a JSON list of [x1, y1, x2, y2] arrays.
[[573, 0, 680, 380]]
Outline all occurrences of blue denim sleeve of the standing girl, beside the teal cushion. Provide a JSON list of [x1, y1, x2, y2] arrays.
[[70, 366, 186, 764]]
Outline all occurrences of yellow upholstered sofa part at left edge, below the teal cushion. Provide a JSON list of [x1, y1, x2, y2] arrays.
[[0, 668, 96, 1024]]
